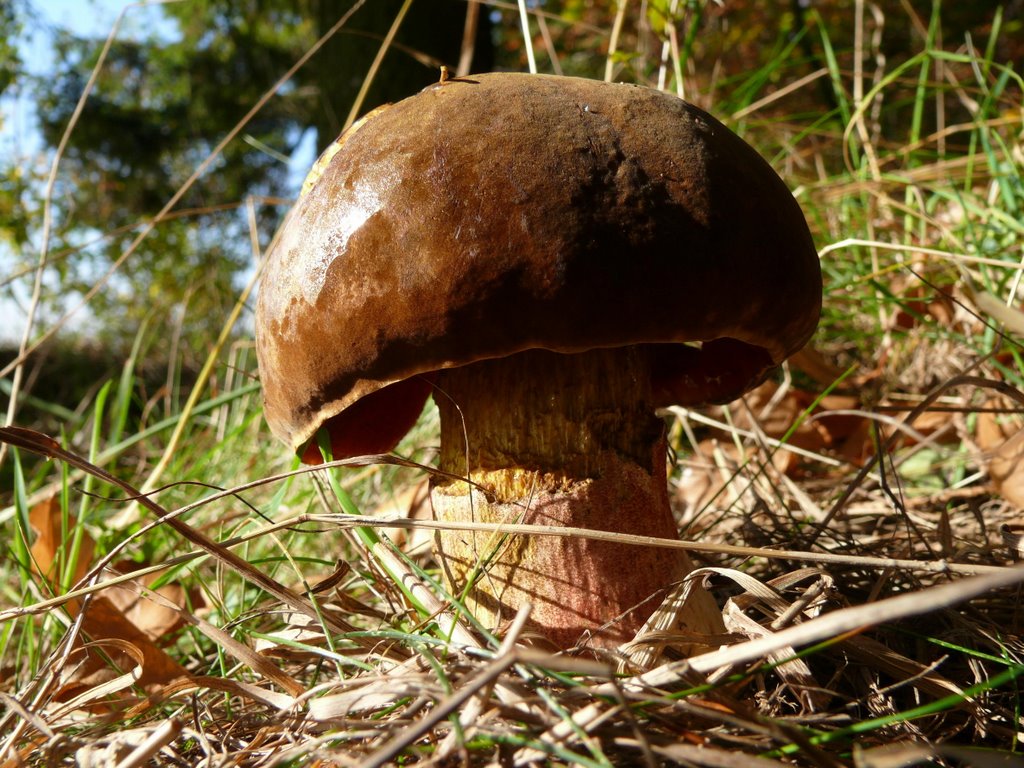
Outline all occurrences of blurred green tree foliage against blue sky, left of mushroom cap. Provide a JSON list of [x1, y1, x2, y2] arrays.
[[24, 0, 487, 351]]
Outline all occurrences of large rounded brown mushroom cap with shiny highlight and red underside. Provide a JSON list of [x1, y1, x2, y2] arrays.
[[256, 74, 821, 461]]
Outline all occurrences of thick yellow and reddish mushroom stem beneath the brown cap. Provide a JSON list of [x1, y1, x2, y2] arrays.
[[431, 347, 721, 647]]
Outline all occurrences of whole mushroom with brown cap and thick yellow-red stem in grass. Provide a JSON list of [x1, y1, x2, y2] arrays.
[[256, 74, 821, 647]]
